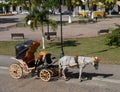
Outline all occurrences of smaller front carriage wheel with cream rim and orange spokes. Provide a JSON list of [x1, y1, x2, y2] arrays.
[[39, 69, 51, 82]]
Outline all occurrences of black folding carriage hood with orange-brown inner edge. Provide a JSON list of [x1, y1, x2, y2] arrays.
[[15, 40, 40, 67]]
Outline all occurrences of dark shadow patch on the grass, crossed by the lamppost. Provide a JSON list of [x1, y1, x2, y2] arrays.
[[49, 40, 80, 48]]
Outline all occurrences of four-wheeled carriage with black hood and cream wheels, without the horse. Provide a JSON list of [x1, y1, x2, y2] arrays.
[[9, 40, 58, 81]]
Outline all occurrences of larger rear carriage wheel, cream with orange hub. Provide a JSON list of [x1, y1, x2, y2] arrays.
[[9, 64, 23, 79]]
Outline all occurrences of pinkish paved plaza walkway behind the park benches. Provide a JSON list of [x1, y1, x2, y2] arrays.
[[0, 16, 120, 41]]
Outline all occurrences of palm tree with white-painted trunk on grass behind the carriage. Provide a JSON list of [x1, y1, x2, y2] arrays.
[[25, 8, 57, 49]]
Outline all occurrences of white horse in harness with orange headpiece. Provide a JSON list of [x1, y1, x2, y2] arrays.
[[59, 56, 100, 81]]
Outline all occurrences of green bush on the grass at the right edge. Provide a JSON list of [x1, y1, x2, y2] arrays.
[[105, 25, 120, 46]]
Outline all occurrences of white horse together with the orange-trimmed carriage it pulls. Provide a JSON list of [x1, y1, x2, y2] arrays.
[[9, 40, 100, 81]]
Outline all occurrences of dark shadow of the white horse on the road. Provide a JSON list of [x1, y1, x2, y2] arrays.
[[66, 72, 113, 80]]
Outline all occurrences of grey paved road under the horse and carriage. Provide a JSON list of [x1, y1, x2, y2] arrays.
[[0, 56, 120, 92]]
